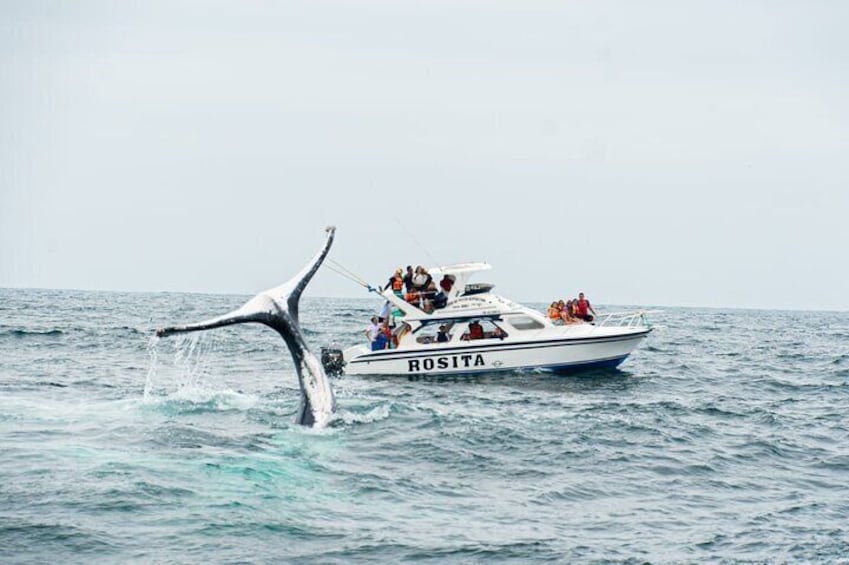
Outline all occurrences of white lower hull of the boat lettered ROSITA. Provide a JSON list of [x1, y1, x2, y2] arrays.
[[345, 329, 651, 375]]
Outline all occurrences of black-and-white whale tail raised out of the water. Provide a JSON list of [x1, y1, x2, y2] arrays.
[[156, 226, 336, 427]]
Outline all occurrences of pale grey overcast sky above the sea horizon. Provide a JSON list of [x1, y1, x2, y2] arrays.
[[0, 0, 849, 310]]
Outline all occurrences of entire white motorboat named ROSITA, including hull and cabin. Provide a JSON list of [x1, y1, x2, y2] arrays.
[[322, 263, 651, 375]]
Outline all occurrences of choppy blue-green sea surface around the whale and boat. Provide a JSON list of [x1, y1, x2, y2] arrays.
[[0, 289, 849, 564]]
